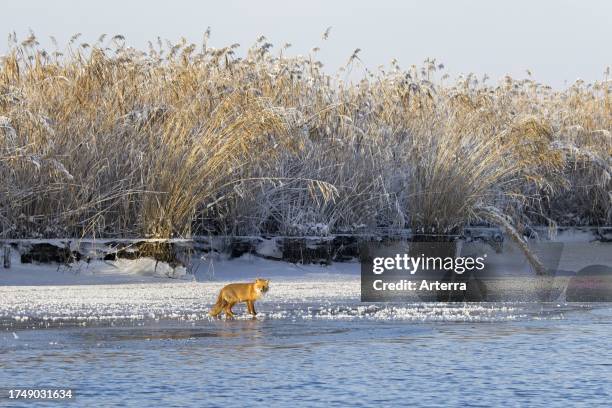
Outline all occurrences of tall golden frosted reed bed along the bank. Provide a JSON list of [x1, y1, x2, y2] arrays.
[[0, 35, 612, 242]]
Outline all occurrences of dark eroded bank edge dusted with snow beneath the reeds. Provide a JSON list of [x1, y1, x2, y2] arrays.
[[0, 227, 612, 277]]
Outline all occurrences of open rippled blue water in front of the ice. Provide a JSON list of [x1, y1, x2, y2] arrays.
[[0, 304, 612, 407]]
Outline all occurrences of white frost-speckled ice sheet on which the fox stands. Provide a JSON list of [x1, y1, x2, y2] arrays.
[[0, 277, 548, 326]]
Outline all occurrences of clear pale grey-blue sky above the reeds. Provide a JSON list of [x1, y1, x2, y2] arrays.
[[0, 0, 612, 87]]
